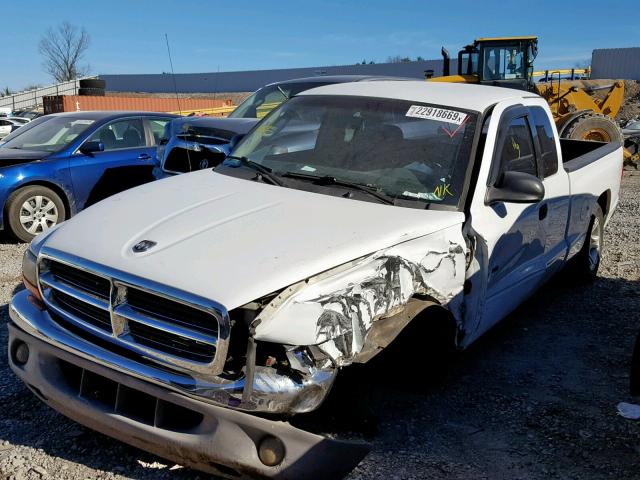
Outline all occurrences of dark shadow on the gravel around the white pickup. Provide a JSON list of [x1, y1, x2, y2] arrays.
[[0, 274, 640, 480]]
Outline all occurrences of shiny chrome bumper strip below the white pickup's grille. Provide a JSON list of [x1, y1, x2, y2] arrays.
[[9, 290, 337, 414]]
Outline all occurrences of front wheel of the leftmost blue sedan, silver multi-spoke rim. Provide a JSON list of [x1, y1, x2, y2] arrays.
[[6, 185, 67, 242]]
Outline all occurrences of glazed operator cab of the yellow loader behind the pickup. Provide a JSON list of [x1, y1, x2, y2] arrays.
[[458, 37, 538, 90]]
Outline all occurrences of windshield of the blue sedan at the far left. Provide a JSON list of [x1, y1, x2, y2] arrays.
[[3, 116, 94, 152]]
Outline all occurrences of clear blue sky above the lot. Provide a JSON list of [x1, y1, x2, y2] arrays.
[[0, 0, 640, 89]]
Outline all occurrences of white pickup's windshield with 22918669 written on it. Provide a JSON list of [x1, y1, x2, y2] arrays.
[[233, 95, 477, 205]]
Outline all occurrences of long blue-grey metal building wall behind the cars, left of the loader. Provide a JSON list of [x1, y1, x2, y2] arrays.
[[100, 60, 457, 93]]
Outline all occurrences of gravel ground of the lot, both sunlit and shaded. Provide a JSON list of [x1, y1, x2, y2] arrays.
[[0, 171, 640, 480]]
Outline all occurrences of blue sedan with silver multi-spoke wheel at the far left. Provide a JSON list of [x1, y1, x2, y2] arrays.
[[0, 112, 176, 242]]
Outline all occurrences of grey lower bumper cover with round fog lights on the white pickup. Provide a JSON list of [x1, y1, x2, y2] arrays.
[[9, 316, 369, 479]]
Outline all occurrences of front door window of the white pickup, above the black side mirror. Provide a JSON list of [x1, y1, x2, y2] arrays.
[[500, 117, 538, 176]]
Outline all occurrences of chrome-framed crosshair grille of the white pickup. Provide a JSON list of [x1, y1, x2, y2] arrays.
[[38, 252, 229, 376]]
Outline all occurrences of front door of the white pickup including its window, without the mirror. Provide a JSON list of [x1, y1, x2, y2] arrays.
[[464, 101, 548, 344]]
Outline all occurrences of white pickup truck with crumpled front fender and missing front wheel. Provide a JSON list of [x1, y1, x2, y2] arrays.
[[9, 81, 623, 479]]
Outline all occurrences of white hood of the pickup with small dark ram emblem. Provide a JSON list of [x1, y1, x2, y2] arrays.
[[44, 170, 464, 310]]
